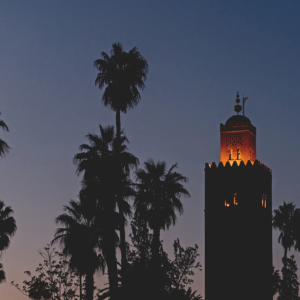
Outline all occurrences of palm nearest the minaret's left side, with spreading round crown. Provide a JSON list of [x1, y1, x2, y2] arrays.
[[134, 159, 190, 288]]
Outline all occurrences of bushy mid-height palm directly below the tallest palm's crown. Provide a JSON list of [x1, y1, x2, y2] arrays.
[[74, 125, 138, 297]]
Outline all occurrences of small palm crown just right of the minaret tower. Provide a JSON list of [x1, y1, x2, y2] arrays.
[[272, 201, 300, 259]]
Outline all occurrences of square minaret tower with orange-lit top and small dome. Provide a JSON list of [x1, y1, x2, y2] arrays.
[[205, 94, 273, 300]]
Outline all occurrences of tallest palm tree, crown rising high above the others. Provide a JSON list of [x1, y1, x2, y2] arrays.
[[94, 43, 148, 284]]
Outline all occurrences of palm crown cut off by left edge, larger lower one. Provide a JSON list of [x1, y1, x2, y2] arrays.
[[0, 200, 17, 253]]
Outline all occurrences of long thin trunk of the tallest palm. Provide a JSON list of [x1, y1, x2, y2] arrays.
[[116, 109, 127, 288]]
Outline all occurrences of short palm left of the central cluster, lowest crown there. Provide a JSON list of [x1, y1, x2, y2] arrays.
[[52, 194, 104, 300]]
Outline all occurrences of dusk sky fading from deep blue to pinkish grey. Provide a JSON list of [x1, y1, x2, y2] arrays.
[[0, 0, 300, 300]]
